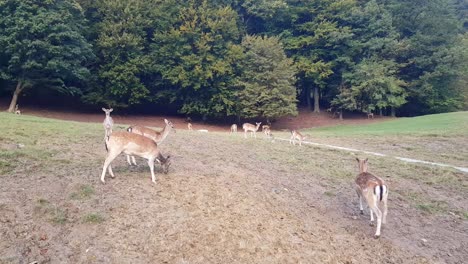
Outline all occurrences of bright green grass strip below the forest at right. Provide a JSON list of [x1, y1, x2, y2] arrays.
[[307, 112, 468, 137]]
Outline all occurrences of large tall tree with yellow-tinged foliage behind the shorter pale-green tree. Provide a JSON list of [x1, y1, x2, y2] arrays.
[[152, 0, 242, 117]]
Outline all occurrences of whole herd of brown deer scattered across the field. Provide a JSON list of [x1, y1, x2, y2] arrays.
[[101, 108, 388, 238]]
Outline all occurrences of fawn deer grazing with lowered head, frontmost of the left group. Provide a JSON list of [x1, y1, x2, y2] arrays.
[[101, 131, 171, 183]]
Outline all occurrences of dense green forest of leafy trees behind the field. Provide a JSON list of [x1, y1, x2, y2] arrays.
[[0, 0, 468, 120]]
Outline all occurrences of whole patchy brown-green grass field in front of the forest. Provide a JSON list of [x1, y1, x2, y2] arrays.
[[0, 113, 468, 263]]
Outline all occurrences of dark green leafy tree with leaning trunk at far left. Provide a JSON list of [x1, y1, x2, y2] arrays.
[[0, 0, 93, 112]]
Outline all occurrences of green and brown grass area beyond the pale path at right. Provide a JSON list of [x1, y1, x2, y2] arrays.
[[268, 112, 468, 167]]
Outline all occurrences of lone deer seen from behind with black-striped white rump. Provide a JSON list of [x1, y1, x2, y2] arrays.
[[355, 158, 388, 238]]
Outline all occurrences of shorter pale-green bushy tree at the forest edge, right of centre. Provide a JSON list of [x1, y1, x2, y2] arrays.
[[238, 36, 297, 119]]
